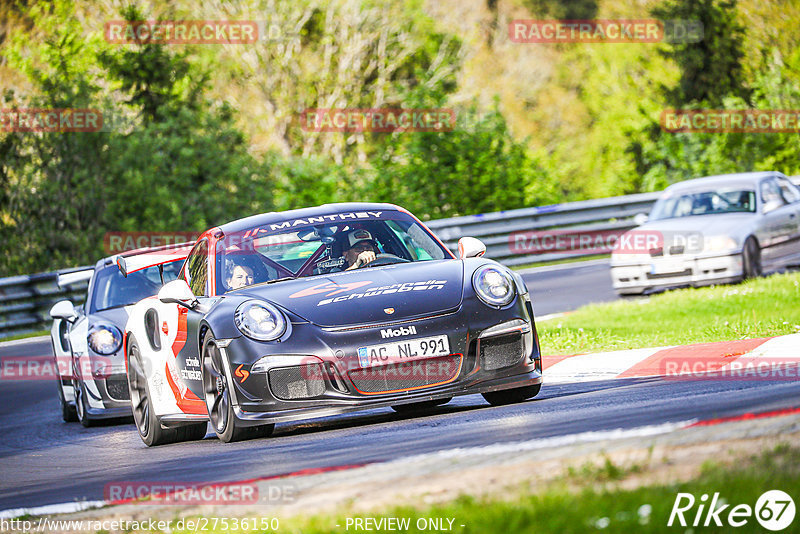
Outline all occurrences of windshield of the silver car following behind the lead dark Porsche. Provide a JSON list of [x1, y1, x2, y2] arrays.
[[91, 259, 183, 313]]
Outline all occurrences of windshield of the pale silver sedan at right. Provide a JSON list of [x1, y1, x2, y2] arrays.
[[650, 190, 756, 221]]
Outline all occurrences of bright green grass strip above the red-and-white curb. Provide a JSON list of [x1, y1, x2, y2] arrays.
[[538, 273, 800, 354]]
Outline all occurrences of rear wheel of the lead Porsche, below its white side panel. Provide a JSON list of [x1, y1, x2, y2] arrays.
[[125, 335, 182, 447]]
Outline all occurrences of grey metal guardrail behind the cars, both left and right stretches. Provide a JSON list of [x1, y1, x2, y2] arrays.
[[6, 176, 800, 339]]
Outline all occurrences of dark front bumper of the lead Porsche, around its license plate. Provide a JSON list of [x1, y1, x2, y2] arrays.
[[224, 298, 542, 426]]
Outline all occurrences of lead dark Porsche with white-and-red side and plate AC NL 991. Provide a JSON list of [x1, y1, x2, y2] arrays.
[[124, 203, 542, 445]]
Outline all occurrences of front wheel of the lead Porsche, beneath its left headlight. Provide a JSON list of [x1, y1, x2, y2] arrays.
[[202, 332, 275, 443]]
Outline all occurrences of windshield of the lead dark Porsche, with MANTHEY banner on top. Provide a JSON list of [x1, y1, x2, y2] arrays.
[[216, 212, 450, 292]]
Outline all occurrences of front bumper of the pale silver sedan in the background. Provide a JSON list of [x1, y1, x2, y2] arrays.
[[611, 252, 744, 294]]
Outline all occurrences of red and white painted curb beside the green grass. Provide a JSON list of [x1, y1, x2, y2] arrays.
[[542, 334, 800, 384]]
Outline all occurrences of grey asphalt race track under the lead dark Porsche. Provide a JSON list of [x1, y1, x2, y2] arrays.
[[0, 267, 800, 510]]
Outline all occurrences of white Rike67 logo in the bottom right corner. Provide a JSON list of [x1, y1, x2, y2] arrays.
[[667, 490, 796, 532]]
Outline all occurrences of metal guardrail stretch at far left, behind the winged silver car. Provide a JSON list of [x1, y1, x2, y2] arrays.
[[0, 267, 90, 339]]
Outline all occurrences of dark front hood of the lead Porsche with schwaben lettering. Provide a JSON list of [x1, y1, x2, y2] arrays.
[[235, 260, 464, 326]]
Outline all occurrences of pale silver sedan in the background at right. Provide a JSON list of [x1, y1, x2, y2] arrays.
[[611, 172, 800, 295]]
